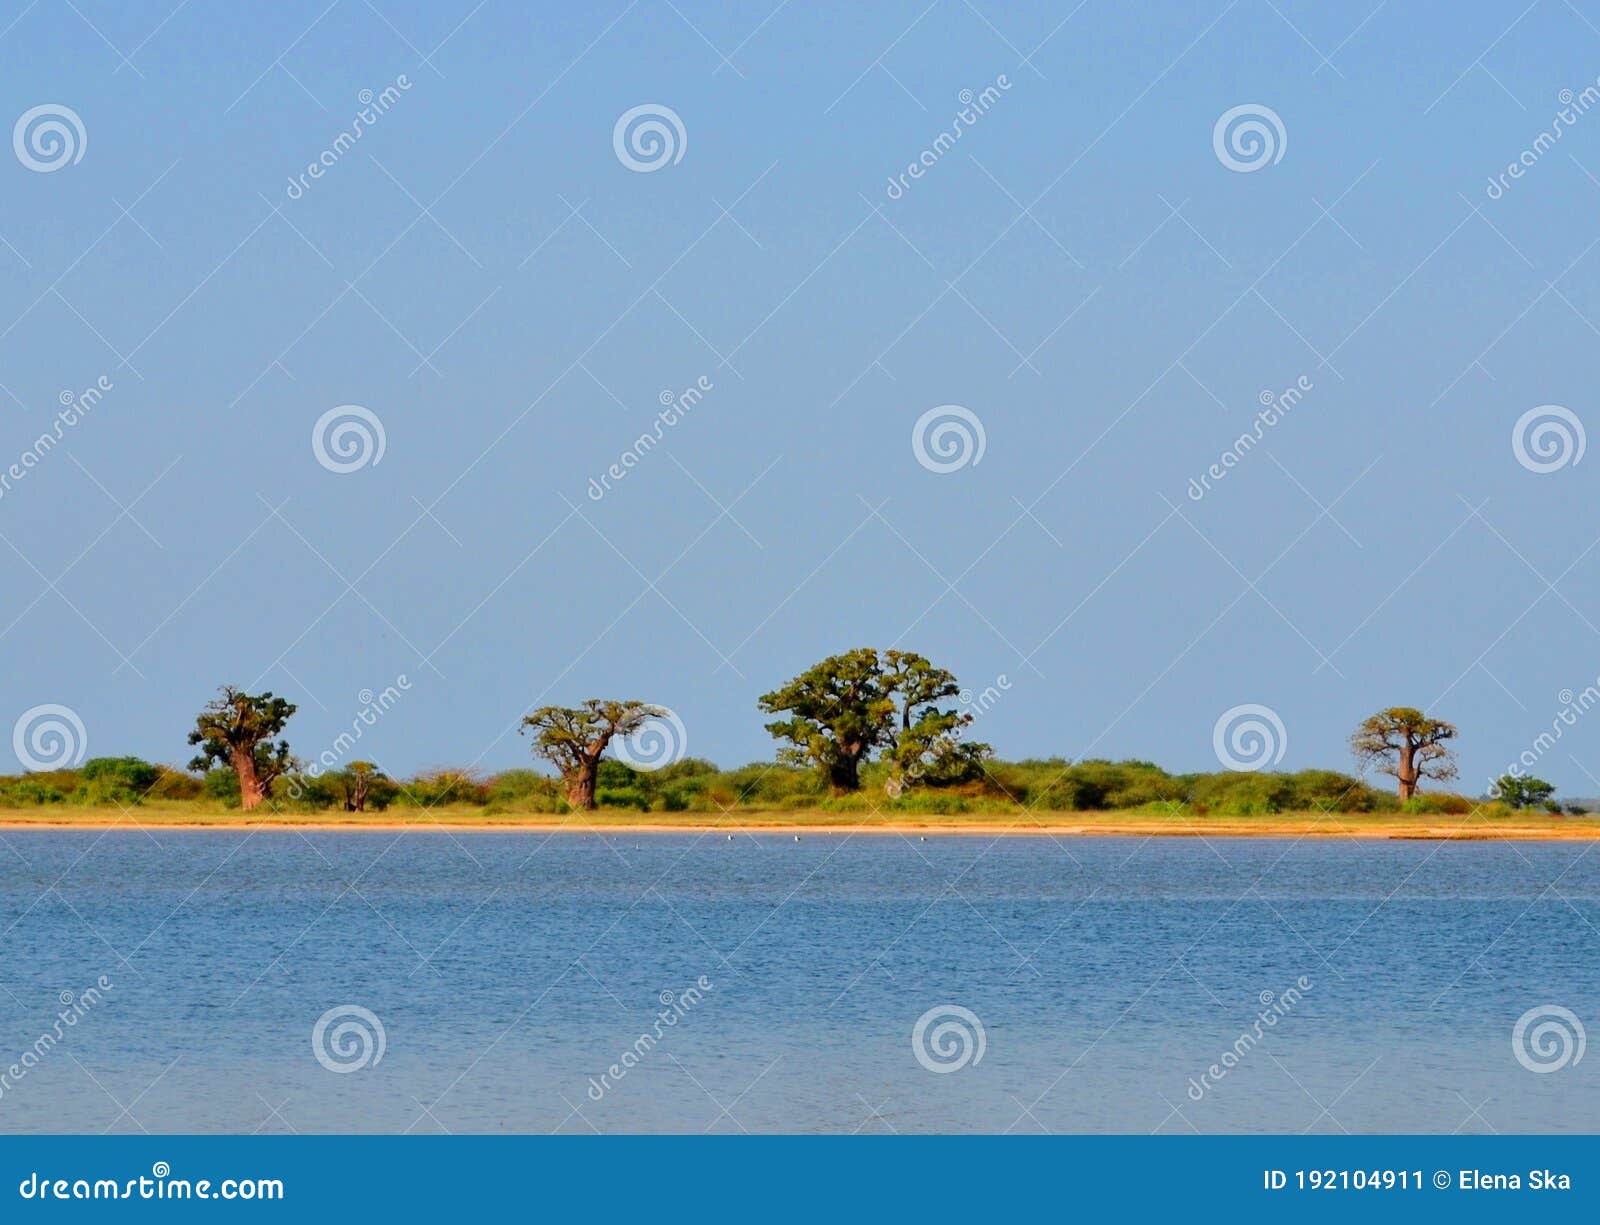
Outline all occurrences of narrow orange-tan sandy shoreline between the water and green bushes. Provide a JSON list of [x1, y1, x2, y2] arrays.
[[0, 811, 1600, 841]]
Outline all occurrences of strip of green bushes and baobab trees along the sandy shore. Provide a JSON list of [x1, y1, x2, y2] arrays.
[[0, 648, 1584, 817]]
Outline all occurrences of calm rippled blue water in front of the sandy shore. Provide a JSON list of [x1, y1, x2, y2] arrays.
[[0, 832, 1600, 1132]]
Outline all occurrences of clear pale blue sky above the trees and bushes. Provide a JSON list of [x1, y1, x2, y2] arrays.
[[0, 0, 1600, 795]]
